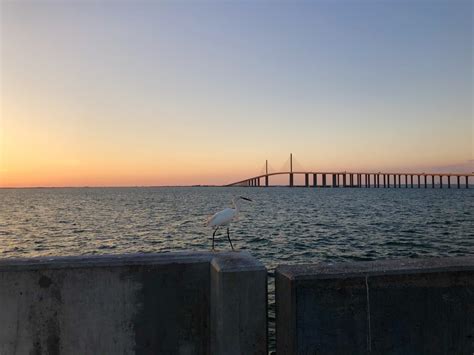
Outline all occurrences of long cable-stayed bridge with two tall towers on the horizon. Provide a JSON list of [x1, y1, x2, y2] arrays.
[[225, 154, 474, 189]]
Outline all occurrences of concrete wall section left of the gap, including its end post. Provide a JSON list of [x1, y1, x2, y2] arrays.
[[0, 253, 267, 355]]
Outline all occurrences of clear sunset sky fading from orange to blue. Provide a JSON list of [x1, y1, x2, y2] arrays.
[[0, 0, 474, 187]]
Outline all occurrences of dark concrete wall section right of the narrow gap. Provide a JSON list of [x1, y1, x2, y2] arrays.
[[276, 257, 474, 355]]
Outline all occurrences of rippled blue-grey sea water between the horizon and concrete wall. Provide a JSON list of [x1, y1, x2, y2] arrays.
[[0, 187, 474, 349]]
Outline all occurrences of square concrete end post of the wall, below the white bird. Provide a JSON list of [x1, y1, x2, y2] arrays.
[[211, 256, 267, 355]]
